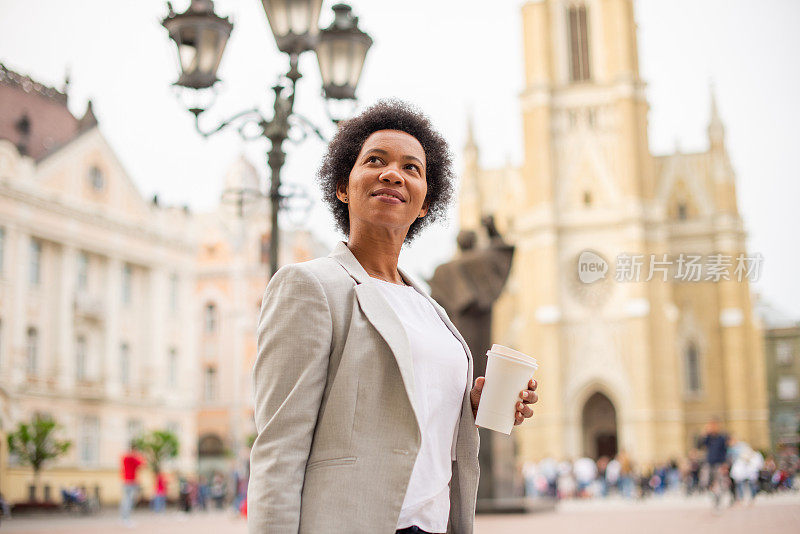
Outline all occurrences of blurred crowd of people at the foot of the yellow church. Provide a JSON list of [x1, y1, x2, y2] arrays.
[[522, 421, 800, 507]]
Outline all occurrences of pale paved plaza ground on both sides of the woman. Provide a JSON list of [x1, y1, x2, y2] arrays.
[[2, 494, 800, 534]]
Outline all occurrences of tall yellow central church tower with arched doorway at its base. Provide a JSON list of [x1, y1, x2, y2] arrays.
[[516, 0, 685, 459]]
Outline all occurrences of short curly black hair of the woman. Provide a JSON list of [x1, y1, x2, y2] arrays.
[[317, 99, 455, 243]]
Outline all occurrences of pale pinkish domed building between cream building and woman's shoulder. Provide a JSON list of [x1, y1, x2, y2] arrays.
[[195, 157, 330, 475]]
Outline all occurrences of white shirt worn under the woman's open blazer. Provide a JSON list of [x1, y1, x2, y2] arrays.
[[372, 277, 469, 532]]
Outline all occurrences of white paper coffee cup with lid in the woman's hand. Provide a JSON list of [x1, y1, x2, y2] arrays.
[[475, 345, 539, 434]]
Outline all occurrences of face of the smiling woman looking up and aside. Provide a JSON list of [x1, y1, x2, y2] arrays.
[[336, 130, 428, 237]]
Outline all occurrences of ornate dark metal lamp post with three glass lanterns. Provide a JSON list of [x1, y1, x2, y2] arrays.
[[166, 0, 372, 276]]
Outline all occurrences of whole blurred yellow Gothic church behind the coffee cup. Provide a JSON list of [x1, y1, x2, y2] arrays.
[[459, 0, 768, 462]]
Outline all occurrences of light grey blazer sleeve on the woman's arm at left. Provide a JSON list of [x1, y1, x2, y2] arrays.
[[247, 264, 333, 534]]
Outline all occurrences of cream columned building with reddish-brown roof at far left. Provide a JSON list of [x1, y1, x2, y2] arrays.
[[0, 61, 197, 502]]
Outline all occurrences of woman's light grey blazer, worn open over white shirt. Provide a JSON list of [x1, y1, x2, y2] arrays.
[[247, 241, 479, 534]]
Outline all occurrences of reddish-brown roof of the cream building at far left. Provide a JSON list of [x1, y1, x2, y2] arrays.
[[0, 63, 97, 160]]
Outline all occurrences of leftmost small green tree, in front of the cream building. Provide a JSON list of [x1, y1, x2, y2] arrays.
[[7, 414, 72, 502]]
